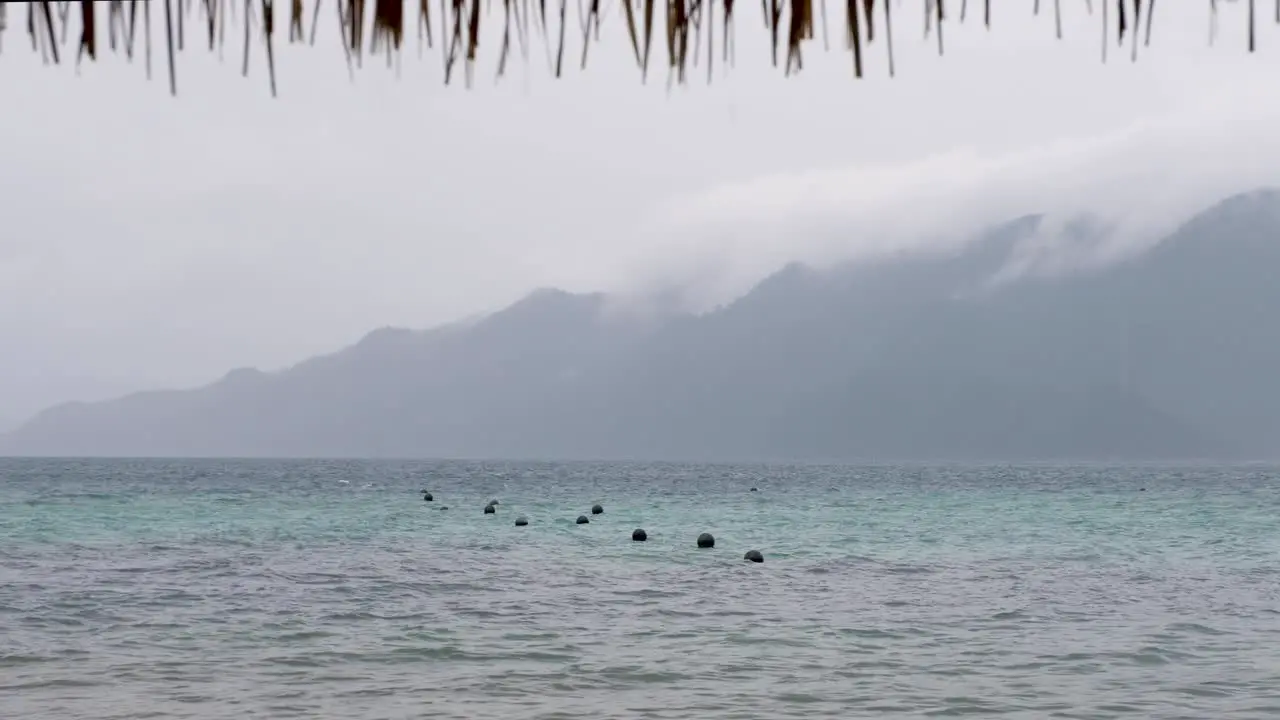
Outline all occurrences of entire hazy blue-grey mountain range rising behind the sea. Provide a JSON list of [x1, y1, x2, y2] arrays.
[[0, 192, 1280, 460]]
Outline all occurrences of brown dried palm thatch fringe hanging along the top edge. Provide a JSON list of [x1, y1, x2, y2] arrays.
[[0, 0, 1280, 95]]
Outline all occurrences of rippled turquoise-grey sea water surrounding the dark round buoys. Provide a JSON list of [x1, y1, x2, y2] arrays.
[[0, 460, 1280, 720]]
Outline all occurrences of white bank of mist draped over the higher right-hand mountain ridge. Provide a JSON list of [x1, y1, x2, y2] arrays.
[[609, 54, 1280, 311]]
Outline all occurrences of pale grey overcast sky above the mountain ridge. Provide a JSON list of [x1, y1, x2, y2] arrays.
[[0, 0, 1280, 427]]
